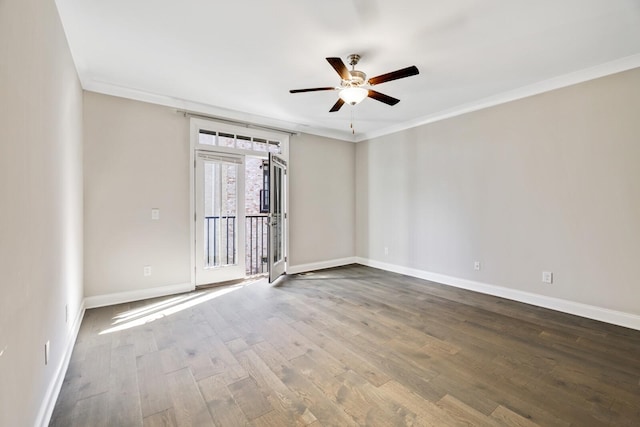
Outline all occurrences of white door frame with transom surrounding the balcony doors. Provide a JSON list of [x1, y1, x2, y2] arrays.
[[189, 115, 293, 289]]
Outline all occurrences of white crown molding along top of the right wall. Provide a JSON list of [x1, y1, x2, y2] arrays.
[[356, 54, 640, 142]]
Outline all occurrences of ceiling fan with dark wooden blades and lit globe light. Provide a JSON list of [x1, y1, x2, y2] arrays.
[[289, 53, 419, 113]]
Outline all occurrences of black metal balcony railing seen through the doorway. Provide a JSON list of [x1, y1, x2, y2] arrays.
[[205, 215, 269, 276]]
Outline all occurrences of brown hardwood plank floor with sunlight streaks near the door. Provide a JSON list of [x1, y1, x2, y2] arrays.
[[50, 265, 640, 427]]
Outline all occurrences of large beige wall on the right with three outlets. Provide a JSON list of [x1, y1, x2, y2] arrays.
[[356, 69, 640, 315]]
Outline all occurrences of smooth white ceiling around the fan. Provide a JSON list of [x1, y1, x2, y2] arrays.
[[56, 0, 640, 140]]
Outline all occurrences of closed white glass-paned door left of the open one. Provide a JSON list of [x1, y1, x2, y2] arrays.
[[194, 151, 245, 286]]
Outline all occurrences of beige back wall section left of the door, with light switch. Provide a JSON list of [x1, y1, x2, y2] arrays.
[[84, 92, 191, 297]]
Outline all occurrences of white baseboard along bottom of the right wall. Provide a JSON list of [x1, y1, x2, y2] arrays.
[[356, 257, 640, 330]]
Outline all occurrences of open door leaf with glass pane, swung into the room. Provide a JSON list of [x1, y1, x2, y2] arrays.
[[269, 154, 287, 282]]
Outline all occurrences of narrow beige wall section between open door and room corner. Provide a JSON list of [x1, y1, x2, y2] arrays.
[[289, 134, 355, 267]]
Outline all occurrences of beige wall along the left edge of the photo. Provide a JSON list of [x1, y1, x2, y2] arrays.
[[0, 0, 82, 426]]
